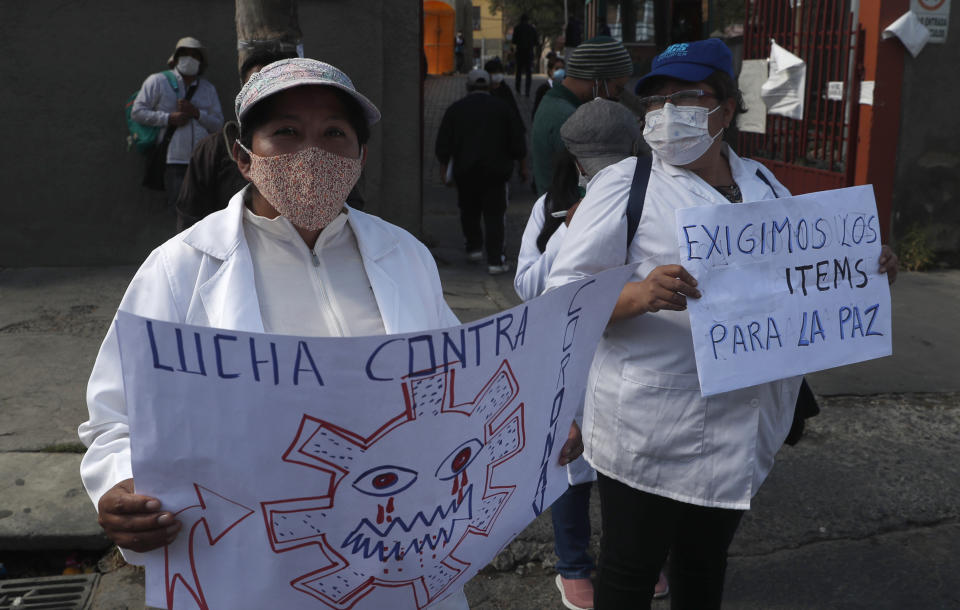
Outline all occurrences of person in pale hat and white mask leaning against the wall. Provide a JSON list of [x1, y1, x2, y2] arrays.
[[130, 36, 223, 208]]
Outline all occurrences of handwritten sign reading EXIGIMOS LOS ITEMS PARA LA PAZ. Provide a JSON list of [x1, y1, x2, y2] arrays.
[[677, 186, 893, 396]]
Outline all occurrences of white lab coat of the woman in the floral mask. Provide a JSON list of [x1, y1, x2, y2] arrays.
[[79, 187, 459, 506]]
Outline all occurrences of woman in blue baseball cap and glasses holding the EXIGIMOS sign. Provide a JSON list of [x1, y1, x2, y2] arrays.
[[547, 39, 897, 610]]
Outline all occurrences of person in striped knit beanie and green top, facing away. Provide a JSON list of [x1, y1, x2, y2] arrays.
[[531, 36, 633, 196]]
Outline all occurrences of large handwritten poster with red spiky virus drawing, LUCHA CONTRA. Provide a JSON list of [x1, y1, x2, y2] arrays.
[[116, 268, 631, 608]]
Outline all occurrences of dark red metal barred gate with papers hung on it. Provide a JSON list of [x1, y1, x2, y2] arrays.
[[738, 0, 863, 194]]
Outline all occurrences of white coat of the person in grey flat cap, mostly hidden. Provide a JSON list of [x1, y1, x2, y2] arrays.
[[513, 194, 597, 485]]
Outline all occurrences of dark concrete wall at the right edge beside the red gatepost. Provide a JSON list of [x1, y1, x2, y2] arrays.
[[891, 13, 960, 256]]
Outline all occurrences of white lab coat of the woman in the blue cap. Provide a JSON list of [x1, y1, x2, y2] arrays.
[[547, 148, 801, 510]]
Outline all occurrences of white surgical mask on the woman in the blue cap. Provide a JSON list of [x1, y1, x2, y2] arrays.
[[643, 102, 723, 165]]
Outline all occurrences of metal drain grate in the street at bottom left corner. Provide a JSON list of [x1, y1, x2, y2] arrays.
[[0, 574, 100, 610]]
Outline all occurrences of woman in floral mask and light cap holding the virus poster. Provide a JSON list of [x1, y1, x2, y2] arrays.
[[79, 58, 467, 610]]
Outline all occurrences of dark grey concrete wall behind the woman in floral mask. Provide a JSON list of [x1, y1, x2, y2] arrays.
[[0, 0, 421, 266]]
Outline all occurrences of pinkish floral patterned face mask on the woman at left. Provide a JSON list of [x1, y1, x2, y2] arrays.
[[240, 144, 363, 231]]
